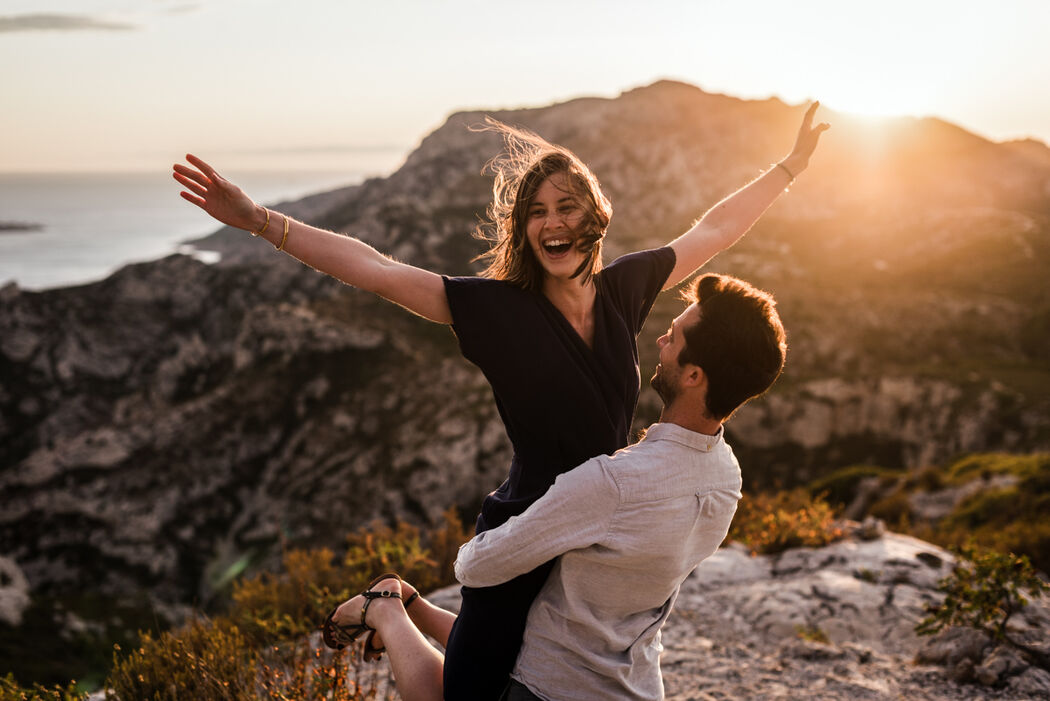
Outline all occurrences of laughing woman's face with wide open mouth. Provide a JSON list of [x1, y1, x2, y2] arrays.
[[525, 173, 587, 279]]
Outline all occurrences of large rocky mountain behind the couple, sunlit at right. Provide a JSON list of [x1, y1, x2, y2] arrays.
[[0, 82, 1050, 621]]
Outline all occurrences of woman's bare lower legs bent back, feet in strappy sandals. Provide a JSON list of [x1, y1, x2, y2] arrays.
[[333, 579, 445, 701]]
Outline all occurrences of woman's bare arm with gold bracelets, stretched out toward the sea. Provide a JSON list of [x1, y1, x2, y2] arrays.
[[172, 155, 453, 323]]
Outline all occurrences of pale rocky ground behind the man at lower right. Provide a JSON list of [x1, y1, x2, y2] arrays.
[[417, 533, 1050, 701]]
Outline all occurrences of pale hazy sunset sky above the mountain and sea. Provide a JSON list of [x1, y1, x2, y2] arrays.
[[0, 0, 1050, 172]]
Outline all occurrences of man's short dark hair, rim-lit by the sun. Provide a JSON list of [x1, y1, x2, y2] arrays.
[[678, 274, 788, 421]]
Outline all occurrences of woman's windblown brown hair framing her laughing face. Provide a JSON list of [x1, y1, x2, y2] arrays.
[[475, 118, 612, 291]]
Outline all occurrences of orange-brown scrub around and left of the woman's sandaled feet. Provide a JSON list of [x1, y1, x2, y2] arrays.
[[103, 510, 469, 701]]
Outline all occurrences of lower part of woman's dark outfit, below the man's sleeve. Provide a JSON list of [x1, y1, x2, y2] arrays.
[[444, 561, 554, 701]]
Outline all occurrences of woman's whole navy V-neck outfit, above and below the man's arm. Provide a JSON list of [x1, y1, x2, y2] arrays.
[[444, 248, 675, 701]]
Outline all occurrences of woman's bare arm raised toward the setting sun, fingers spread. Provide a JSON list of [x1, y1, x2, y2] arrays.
[[664, 102, 828, 290]]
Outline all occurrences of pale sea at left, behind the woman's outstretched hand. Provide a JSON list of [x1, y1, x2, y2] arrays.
[[0, 171, 375, 290]]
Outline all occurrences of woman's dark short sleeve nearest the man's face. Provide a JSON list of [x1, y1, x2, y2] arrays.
[[604, 247, 675, 336]]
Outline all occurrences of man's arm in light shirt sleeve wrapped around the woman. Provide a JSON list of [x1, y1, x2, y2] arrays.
[[456, 458, 620, 587]]
